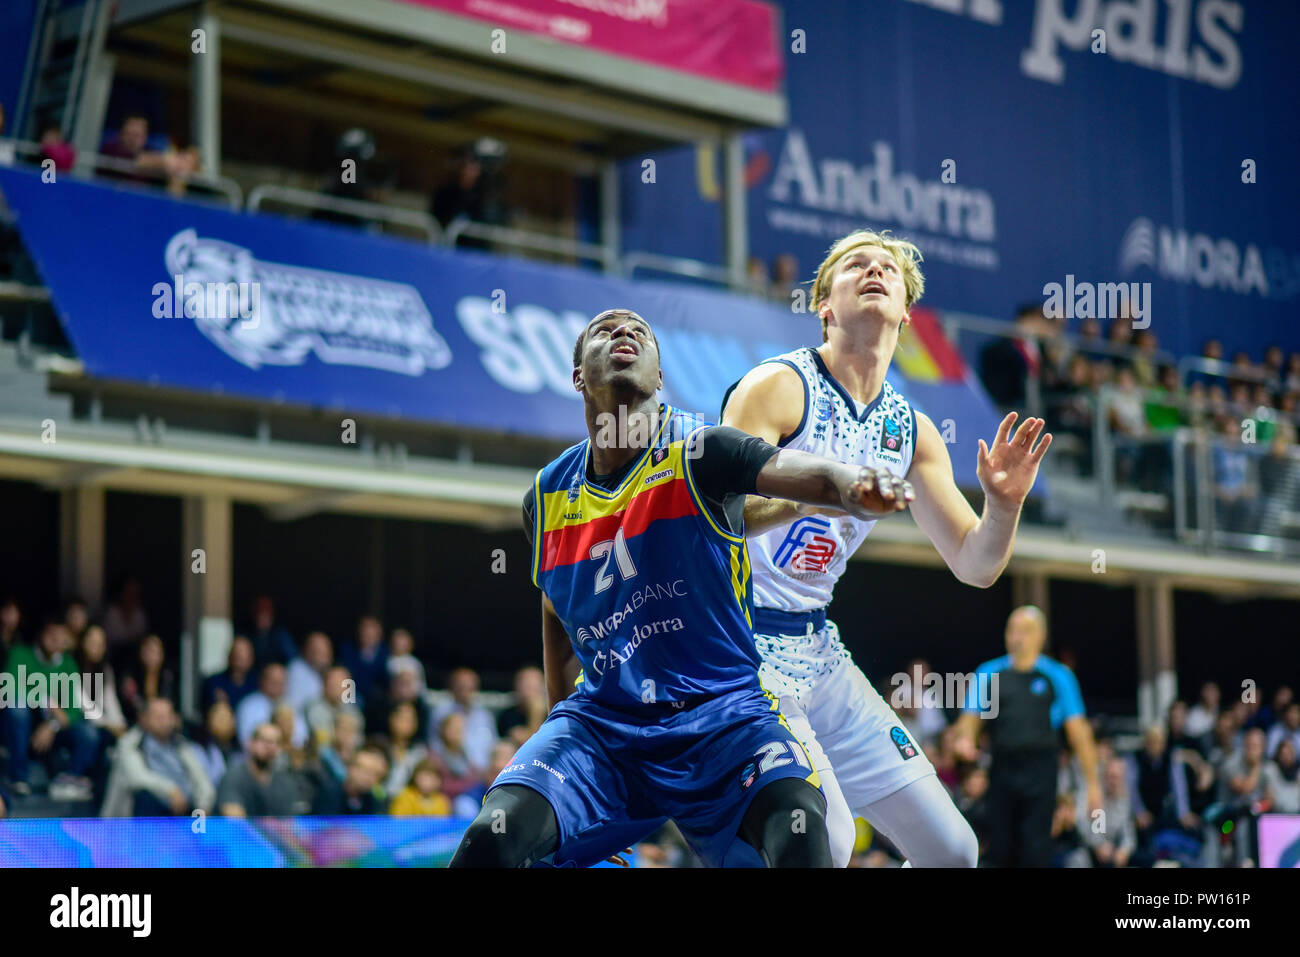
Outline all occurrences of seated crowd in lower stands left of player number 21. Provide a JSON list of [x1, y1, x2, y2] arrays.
[[0, 583, 546, 818]]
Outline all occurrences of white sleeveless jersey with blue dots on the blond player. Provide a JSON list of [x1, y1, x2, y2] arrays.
[[748, 348, 917, 611]]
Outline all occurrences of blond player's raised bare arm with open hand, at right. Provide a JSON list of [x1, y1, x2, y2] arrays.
[[907, 412, 1052, 588]]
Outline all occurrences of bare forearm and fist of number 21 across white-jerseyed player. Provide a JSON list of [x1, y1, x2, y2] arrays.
[[755, 449, 914, 519]]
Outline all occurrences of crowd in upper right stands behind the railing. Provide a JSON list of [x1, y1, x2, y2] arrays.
[[979, 303, 1300, 534]]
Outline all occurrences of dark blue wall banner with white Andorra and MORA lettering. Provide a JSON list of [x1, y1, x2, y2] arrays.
[[623, 0, 1300, 361]]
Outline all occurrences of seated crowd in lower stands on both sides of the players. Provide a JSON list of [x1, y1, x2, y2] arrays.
[[0, 583, 1300, 867]]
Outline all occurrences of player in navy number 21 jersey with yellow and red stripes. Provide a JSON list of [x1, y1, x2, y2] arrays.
[[451, 309, 909, 867]]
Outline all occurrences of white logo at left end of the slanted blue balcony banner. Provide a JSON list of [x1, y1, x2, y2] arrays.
[[153, 229, 451, 376]]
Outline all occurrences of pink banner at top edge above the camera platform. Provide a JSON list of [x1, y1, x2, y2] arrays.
[[403, 0, 783, 92]]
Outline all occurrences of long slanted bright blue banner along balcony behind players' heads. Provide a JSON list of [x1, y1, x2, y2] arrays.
[[0, 169, 997, 481]]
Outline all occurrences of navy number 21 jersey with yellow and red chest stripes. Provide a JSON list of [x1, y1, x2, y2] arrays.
[[533, 404, 759, 711]]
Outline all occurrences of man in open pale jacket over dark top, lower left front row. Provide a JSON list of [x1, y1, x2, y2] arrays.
[[100, 697, 215, 818]]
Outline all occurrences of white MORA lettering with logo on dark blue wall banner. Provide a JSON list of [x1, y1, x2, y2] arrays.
[[1119, 217, 1300, 299]]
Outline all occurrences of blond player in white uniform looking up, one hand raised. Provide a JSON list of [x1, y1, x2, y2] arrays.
[[723, 230, 1052, 867]]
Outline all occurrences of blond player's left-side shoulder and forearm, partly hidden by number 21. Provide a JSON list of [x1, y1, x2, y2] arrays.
[[722, 363, 839, 534]]
